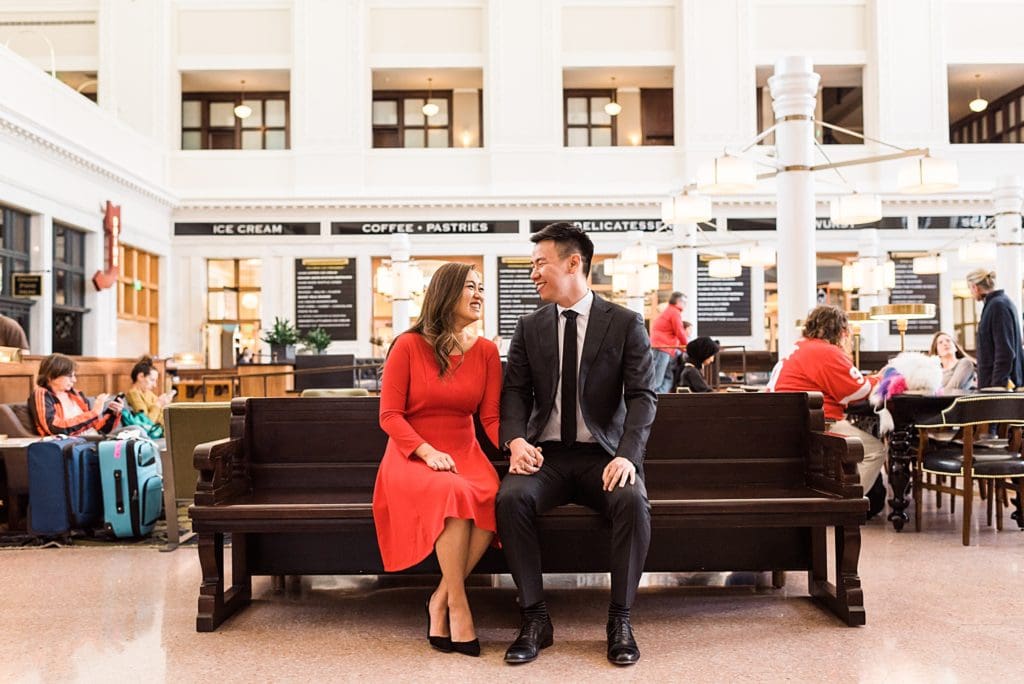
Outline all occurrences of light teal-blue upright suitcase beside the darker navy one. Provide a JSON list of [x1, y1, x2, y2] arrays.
[[99, 439, 164, 537]]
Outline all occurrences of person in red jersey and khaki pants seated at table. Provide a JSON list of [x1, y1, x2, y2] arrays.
[[768, 304, 885, 494]]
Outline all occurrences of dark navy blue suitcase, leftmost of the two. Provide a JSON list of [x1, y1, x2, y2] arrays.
[[28, 437, 103, 537]]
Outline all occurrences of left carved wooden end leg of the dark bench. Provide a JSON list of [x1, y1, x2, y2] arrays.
[[196, 532, 252, 632]]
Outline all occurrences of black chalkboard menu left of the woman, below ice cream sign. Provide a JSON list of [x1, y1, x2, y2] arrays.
[[295, 259, 355, 340]]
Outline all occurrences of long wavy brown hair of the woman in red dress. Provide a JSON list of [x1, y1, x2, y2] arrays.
[[409, 262, 474, 378]]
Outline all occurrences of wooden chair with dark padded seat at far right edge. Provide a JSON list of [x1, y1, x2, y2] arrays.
[[913, 394, 1024, 546]]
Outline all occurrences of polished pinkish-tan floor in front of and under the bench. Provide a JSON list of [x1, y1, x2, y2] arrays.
[[0, 497, 1024, 683]]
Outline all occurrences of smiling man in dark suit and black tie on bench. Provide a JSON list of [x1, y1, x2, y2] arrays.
[[497, 223, 657, 666]]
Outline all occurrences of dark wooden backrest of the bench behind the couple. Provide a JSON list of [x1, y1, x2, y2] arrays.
[[231, 393, 824, 498]]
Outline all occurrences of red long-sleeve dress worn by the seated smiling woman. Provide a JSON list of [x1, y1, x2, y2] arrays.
[[374, 333, 502, 571]]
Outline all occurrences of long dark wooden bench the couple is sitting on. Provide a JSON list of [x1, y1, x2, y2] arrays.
[[189, 393, 867, 632]]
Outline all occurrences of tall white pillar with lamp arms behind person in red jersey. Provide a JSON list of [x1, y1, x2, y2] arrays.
[[768, 57, 820, 354]]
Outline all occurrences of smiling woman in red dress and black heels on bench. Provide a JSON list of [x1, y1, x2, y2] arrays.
[[374, 263, 502, 655]]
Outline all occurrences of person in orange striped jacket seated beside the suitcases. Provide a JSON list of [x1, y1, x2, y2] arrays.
[[29, 354, 124, 437]]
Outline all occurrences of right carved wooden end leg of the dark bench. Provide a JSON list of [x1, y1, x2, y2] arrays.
[[809, 525, 865, 627]]
